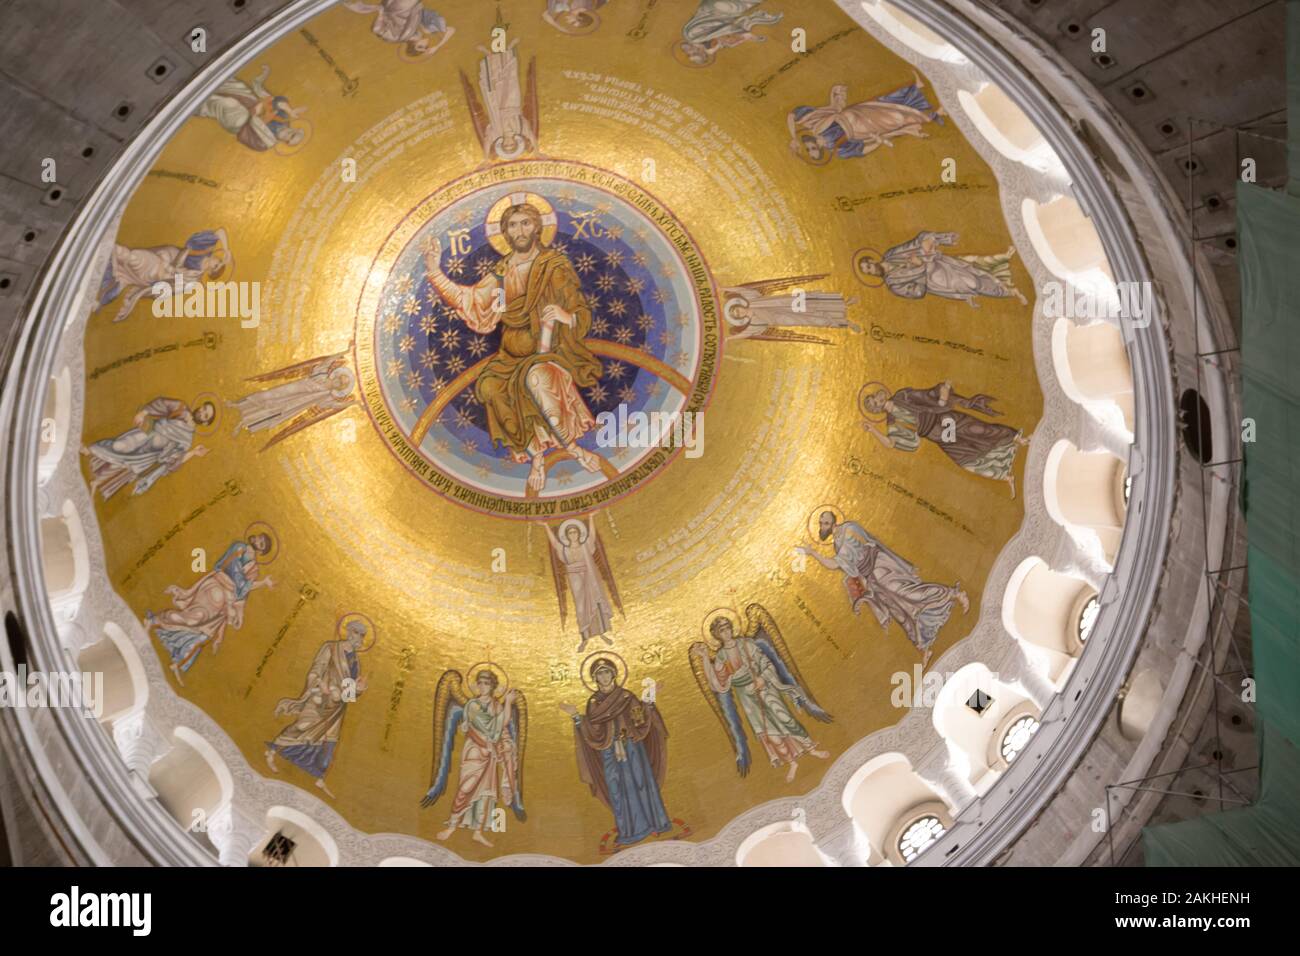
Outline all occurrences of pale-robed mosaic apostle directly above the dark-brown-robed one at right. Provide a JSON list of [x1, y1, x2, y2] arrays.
[[855, 232, 1028, 308]]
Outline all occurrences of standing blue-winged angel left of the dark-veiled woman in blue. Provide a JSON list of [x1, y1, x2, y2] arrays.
[[420, 666, 528, 847]]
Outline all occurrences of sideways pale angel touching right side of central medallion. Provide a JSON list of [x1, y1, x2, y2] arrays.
[[723, 274, 862, 345]]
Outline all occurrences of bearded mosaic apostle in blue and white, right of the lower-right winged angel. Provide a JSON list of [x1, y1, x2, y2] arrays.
[[796, 511, 970, 667]]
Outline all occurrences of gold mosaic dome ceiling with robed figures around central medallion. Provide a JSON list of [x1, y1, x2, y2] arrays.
[[82, 0, 1043, 862]]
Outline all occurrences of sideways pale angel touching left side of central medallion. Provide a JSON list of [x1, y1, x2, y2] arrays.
[[228, 351, 356, 451]]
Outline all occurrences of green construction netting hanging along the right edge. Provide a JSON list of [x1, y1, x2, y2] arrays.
[[1143, 157, 1300, 866]]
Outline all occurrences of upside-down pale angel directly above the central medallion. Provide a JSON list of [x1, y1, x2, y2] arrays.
[[460, 40, 538, 163]]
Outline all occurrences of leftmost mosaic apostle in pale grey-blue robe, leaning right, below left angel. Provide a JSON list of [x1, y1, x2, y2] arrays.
[[82, 398, 217, 501]]
